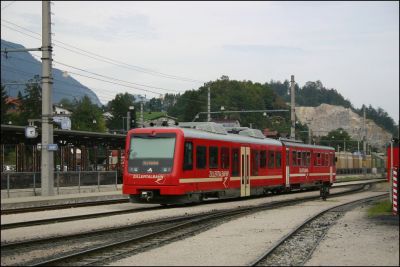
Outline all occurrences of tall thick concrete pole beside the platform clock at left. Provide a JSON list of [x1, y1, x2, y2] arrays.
[[41, 1, 54, 196]]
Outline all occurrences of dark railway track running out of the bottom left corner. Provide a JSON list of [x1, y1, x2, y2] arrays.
[[1, 185, 376, 266]]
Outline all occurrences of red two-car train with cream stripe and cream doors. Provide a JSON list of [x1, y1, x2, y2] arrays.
[[123, 123, 336, 204]]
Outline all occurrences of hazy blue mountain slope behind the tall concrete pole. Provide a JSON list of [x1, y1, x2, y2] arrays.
[[1, 40, 101, 106]]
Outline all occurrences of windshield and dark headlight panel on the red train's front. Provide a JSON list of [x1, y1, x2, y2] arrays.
[[128, 133, 176, 173]]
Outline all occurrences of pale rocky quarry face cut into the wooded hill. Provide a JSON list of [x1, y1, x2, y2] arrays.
[[296, 104, 392, 152]]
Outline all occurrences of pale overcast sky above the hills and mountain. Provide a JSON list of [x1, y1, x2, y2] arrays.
[[1, 1, 399, 123]]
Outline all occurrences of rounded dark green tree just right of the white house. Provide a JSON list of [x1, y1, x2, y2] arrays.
[[71, 96, 106, 132]]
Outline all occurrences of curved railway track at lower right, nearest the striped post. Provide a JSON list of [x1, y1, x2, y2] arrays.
[[250, 193, 388, 266]]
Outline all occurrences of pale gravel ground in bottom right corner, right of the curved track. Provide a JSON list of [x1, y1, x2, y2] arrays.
[[305, 206, 399, 266]]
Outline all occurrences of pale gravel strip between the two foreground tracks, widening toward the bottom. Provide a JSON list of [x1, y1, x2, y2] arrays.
[[111, 192, 390, 266]]
